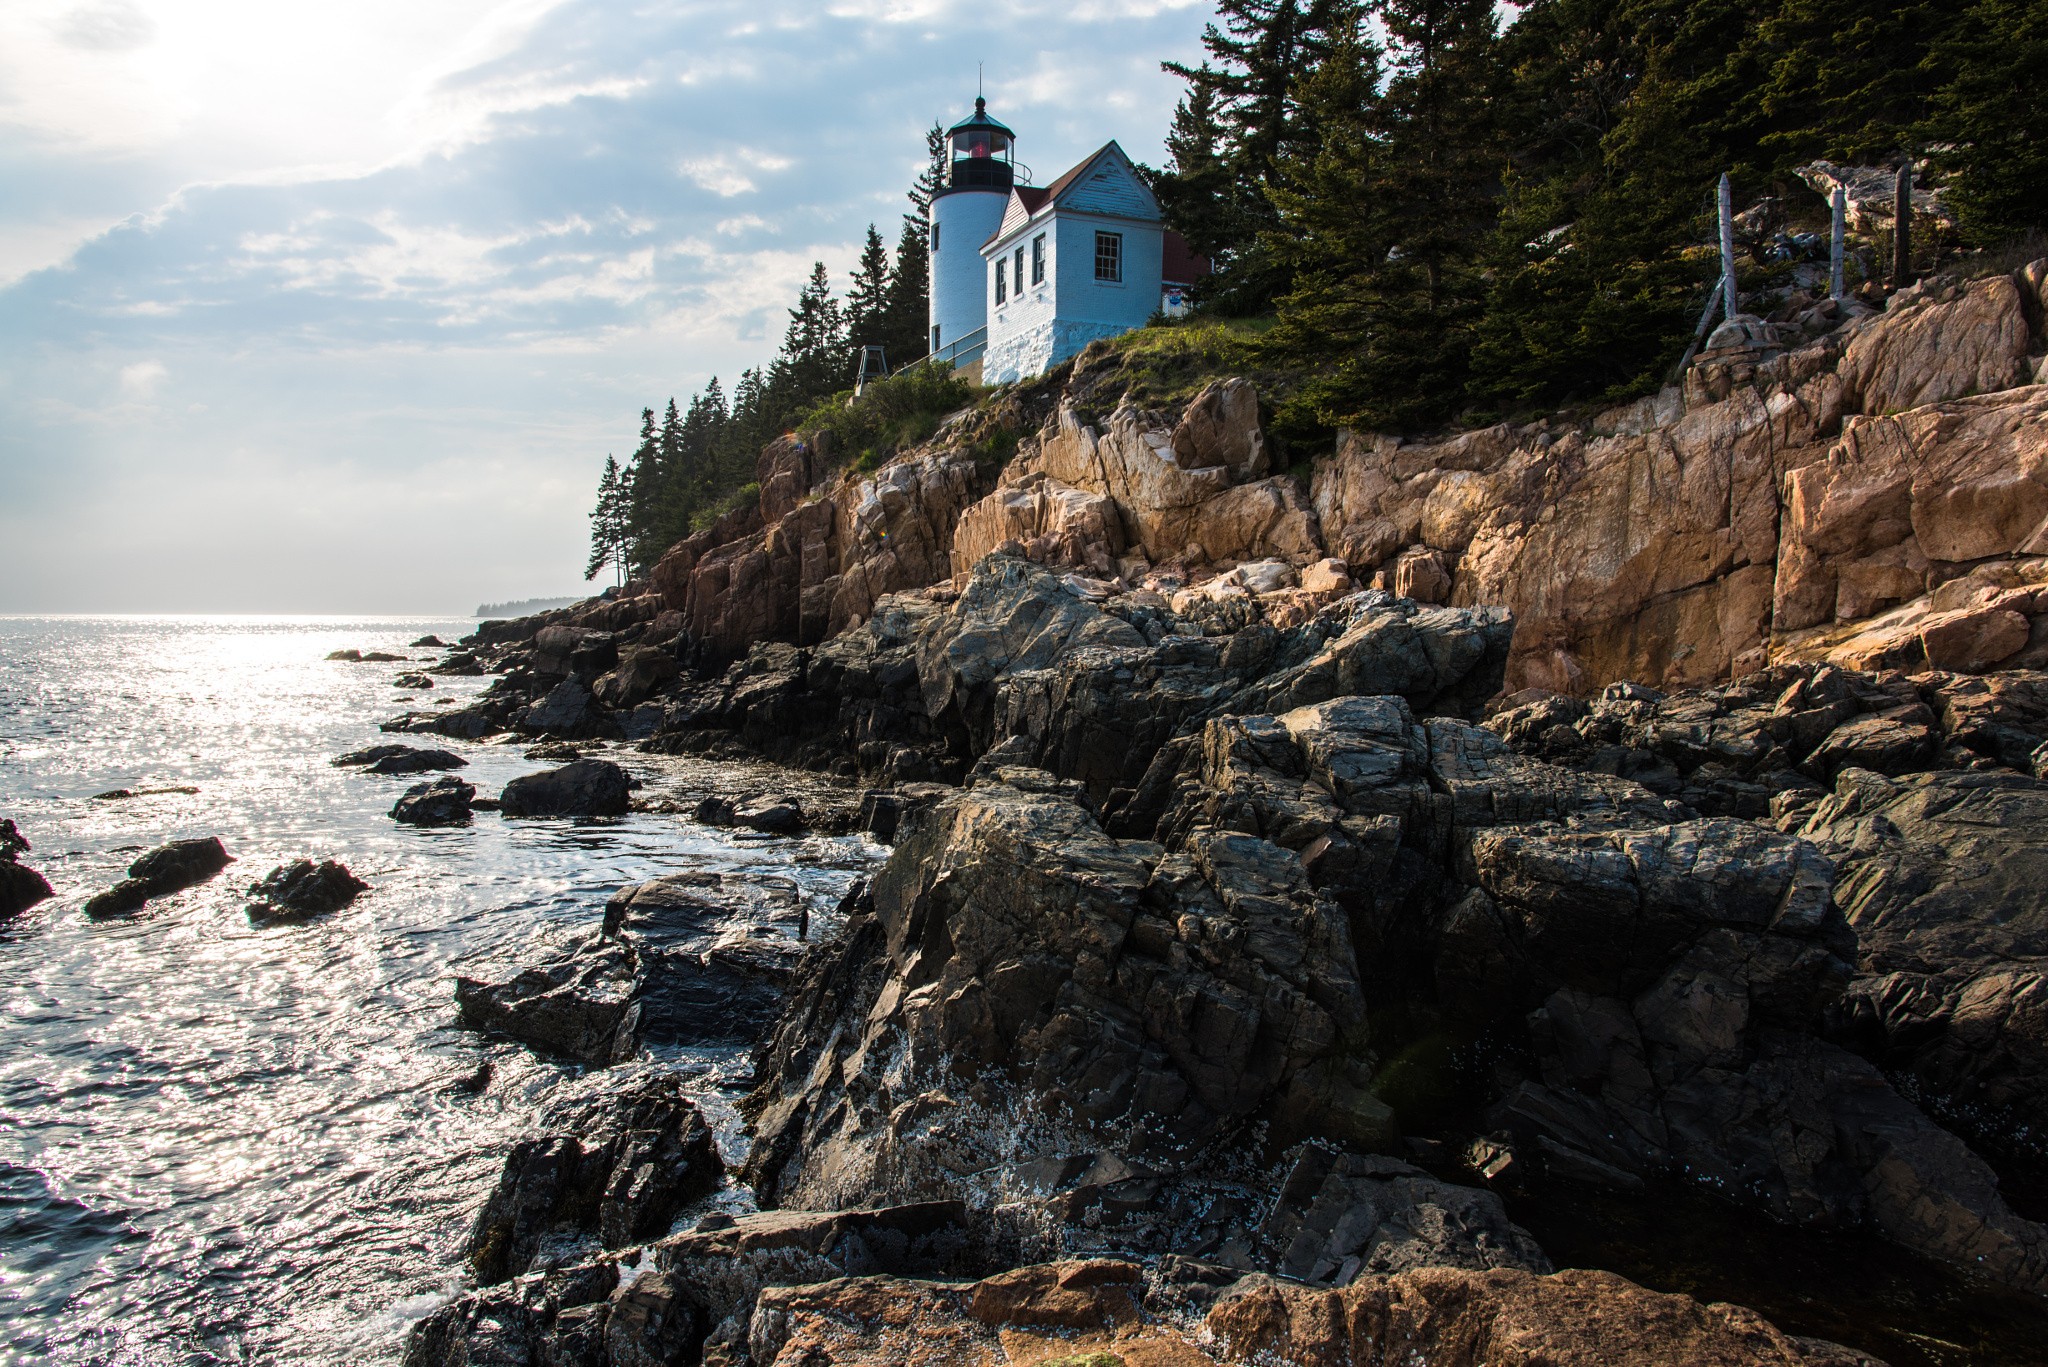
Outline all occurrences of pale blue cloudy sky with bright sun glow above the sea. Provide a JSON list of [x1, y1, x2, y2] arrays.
[[0, 0, 1210, 613]]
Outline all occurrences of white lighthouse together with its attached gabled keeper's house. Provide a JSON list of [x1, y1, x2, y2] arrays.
[[930, 98, 1208, 385]]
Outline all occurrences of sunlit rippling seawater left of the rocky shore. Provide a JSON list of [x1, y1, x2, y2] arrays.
[[0, 617, 881, 1367]]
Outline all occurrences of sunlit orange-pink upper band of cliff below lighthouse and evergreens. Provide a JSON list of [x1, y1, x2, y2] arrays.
[[495, 262, 2048, 695]]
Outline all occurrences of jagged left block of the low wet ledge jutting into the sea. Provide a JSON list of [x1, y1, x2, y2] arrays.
[[455, 937, 639, 1066]]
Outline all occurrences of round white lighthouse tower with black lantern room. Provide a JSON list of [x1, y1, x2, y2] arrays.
[[930, 96, 1016, 367]]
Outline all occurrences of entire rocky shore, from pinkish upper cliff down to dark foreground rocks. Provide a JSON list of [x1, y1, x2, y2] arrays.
[[389, 264, 2048, 1367]]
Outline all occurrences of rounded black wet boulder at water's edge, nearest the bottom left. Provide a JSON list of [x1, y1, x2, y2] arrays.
[[465, 1074, 725, 1285]]
